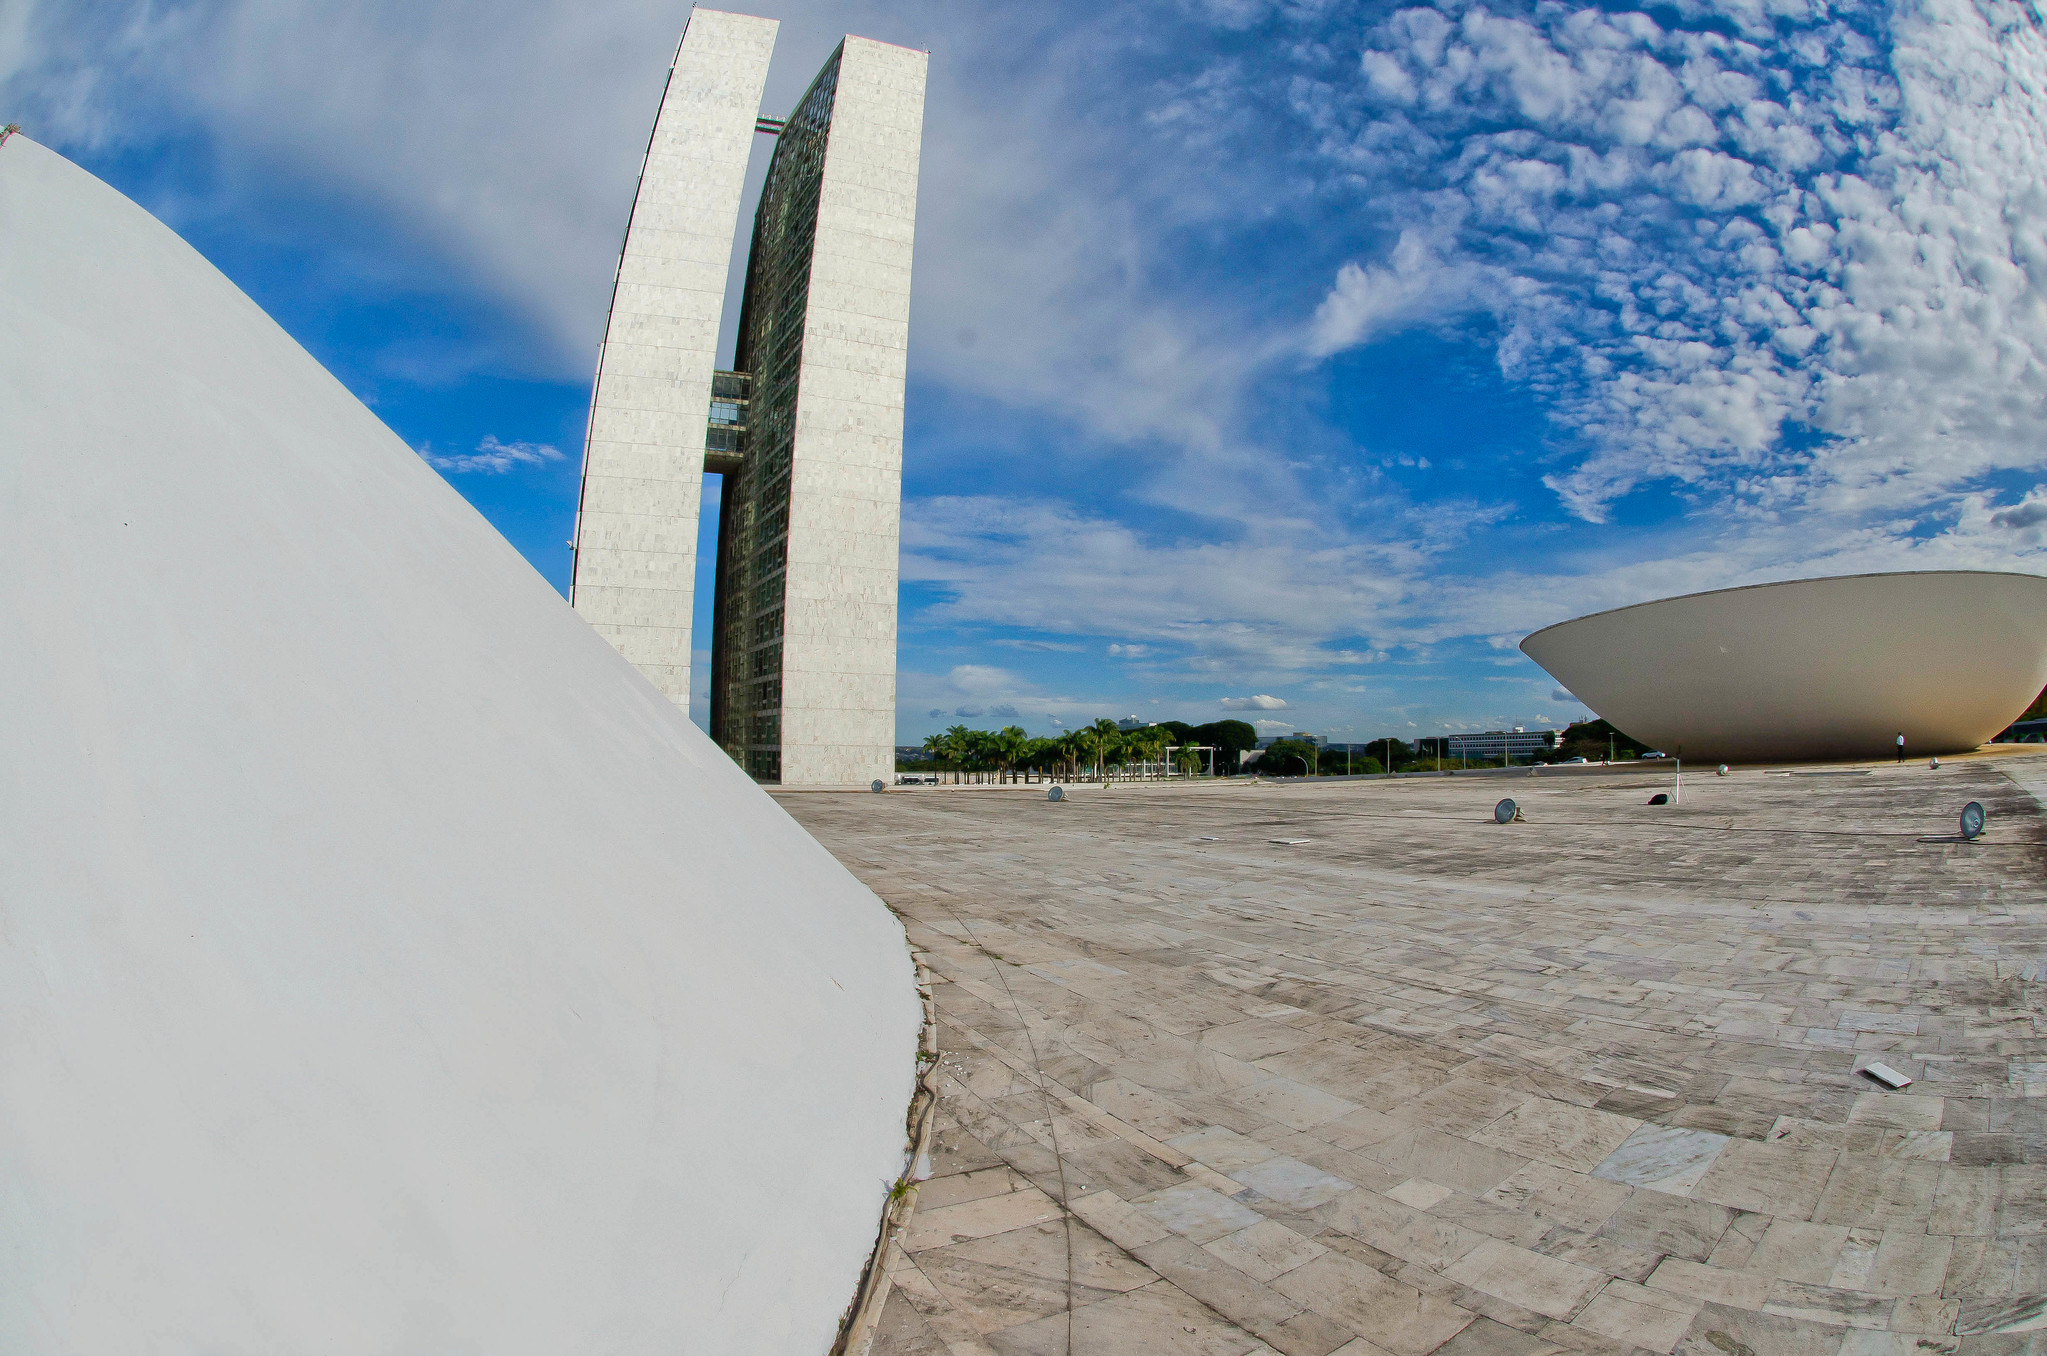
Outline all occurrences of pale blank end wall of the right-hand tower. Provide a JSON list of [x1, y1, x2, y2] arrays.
[[782, 37, 925, 787]]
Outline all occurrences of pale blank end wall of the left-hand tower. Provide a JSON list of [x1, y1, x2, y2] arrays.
[[571, 10, 778, 709]]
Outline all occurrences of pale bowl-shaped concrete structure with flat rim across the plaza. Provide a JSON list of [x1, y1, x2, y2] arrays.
[[1521, 569, 2047, 762]]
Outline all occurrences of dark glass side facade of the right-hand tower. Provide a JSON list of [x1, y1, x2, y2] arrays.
[[710, 49, 843, 782]]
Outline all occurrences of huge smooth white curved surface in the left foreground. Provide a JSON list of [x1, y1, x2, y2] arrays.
[[0, 137, 919, 1356]]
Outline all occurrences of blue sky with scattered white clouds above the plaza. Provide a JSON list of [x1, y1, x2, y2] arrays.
[[12, 0, 2047, 741]]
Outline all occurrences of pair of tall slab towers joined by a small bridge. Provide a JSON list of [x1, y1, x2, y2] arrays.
[[569, 10, 925, 785]]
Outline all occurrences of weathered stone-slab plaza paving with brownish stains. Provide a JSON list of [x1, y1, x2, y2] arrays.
[[782, 758, 2047, 1356]]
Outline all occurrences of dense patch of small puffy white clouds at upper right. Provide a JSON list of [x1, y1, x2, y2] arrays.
[[1300, 0, 2047, 522]]
